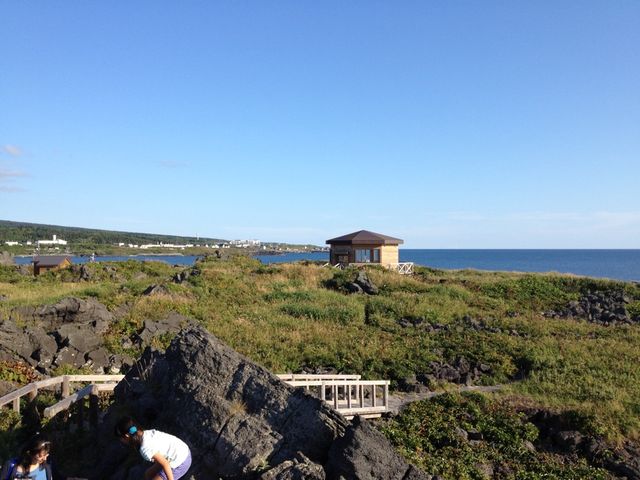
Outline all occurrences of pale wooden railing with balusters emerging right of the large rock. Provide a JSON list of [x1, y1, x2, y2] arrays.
[[278, 374, 389, 418]]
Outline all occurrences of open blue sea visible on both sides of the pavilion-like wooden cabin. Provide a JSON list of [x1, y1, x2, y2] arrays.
[[258, 248, 640, 281]]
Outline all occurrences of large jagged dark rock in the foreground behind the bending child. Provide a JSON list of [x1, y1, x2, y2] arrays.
[[95, 327, 430, 480]]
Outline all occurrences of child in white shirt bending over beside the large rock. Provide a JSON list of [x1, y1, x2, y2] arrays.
[[114, 417, 191, 480]]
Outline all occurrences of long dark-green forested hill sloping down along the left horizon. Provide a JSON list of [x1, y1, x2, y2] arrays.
[[0, 220, 224, 244]]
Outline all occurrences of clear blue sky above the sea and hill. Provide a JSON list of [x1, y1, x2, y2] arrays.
[[0, 0, 640, 248]]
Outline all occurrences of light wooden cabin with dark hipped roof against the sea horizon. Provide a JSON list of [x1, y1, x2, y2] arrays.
[[326, 230, 404, 267]]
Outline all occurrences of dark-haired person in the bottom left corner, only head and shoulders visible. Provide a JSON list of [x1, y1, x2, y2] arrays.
[[0, 434, 53, 480]]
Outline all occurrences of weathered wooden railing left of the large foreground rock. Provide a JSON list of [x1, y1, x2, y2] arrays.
[[0, 375, 124, 420]]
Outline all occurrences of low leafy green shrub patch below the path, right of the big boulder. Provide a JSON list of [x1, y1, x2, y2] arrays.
[[381, 394, 608, 480]]
